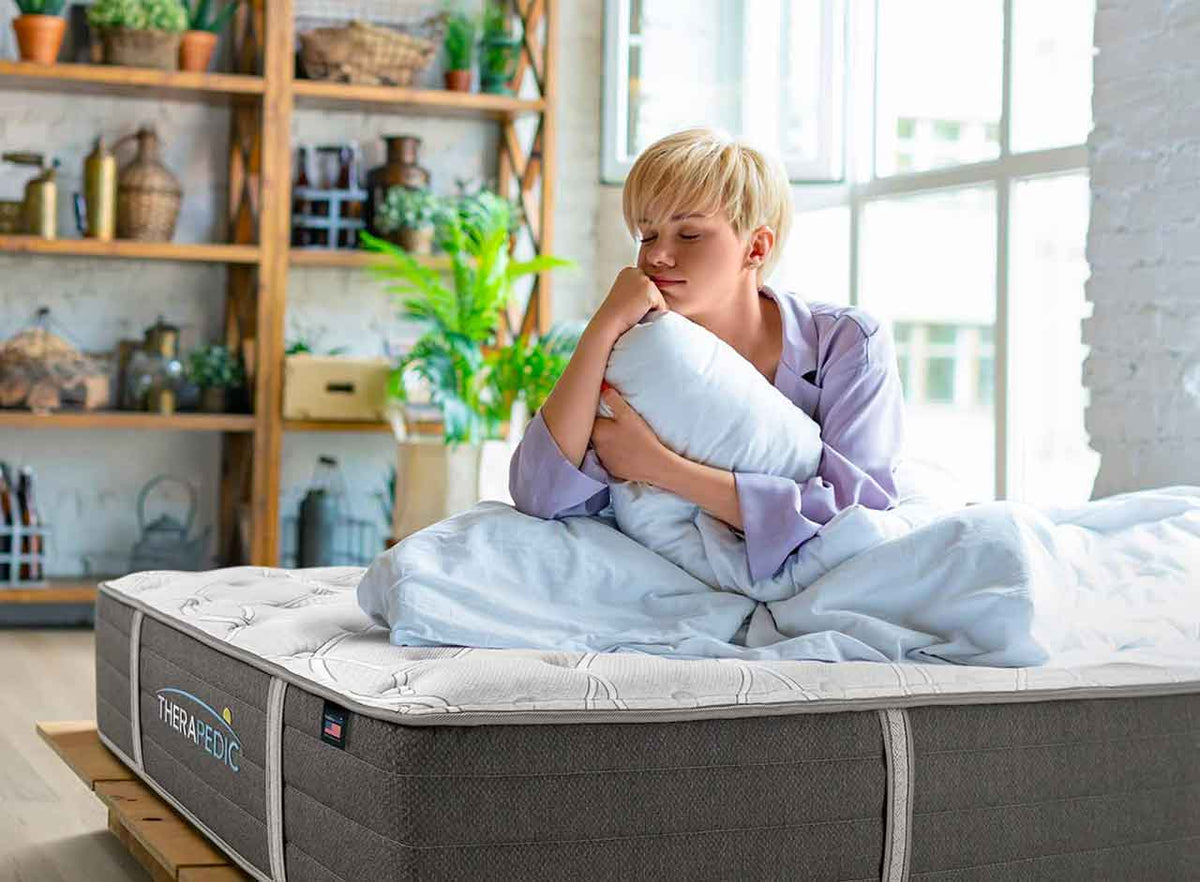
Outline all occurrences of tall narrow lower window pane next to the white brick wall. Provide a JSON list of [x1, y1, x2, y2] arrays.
[[1008, 174, 1100, 504]]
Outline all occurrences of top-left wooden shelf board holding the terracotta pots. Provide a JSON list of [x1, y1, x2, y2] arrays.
[[0, 61, 263, 100]]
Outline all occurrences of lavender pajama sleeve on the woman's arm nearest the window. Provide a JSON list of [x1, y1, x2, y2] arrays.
[[734, 326, 904, 580]]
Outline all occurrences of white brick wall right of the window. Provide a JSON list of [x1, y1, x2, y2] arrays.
[[1084, 0, 1200, 497]]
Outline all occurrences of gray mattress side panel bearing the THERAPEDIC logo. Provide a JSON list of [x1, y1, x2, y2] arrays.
[[138, 618, 270, 872]]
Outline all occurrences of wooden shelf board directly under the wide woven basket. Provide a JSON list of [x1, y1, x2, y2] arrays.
[[292, 79, 546, 119]]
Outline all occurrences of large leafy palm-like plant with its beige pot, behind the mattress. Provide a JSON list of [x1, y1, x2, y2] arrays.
[[362, 191, 572, 538]]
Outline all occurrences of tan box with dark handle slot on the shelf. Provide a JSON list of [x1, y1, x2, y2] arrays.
[[283, 355, 391, 422]]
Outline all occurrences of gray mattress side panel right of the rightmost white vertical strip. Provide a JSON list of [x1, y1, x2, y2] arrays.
[[908, 695, 1200, 882]]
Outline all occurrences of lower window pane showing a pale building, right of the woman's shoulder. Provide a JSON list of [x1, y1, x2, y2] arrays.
[[860, 187, 996, 500]]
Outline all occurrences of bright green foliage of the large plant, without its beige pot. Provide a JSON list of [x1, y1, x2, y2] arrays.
[[362, 191, 574, 444]]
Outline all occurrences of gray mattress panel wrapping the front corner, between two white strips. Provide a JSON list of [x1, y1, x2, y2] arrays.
[[283, 689, 886, 880]]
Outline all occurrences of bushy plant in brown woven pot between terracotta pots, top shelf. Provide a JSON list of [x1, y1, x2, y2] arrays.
[[88, 0, 187, 71]]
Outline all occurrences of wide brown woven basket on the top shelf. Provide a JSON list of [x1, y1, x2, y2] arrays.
[[299, 16, 445, 86]]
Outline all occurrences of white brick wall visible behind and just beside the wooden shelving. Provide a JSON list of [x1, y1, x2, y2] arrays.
[[0, 0, 604, 575]]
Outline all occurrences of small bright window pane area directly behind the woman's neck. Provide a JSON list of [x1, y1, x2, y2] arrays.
[[767, 205, 850, 304]]
